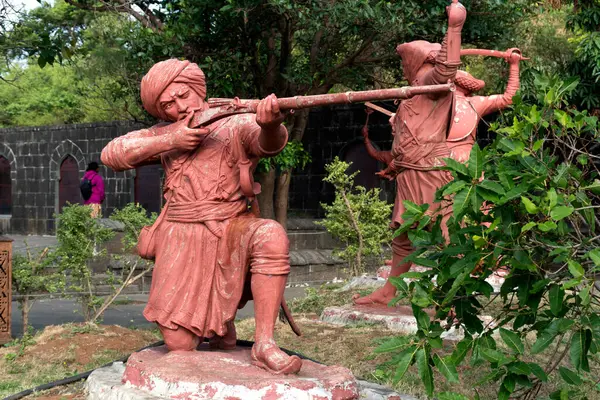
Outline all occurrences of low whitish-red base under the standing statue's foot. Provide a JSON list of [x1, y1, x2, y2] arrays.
[[321, 304, 492, 341]]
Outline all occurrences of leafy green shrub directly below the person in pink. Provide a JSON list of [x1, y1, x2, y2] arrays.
[[55, 204, 114, 321]]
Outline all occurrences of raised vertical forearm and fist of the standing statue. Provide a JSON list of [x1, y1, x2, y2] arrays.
[[421, 0, 467, 85]]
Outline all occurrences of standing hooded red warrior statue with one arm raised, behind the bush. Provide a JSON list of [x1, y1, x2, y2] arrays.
[[354, 0, 467, 305]]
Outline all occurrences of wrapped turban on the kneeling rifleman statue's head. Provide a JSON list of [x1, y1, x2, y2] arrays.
[[141, 58, 206, 120]]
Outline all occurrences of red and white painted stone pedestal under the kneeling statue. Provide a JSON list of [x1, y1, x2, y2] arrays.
[[87, 344, 359, 400]]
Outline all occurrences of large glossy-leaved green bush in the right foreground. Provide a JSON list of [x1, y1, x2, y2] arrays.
[[382, 76, 600, 399]]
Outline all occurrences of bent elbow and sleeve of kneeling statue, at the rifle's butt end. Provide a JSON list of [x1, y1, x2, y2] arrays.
[[100, 127, 173, 171]]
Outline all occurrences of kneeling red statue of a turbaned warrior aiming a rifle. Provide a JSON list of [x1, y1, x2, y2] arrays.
[[102, 59, 302, 374]]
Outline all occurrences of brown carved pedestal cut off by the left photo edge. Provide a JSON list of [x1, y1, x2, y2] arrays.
[[0, 236, 13, 344]]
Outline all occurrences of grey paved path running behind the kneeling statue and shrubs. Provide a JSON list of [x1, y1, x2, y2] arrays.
[[11, 287, 304, 337]]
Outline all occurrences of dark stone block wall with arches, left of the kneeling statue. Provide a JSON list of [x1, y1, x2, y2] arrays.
[[0, 122, 144, 234]]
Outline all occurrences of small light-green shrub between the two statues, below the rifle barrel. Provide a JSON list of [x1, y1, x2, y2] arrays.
[[320, 157, 392, 276]]
